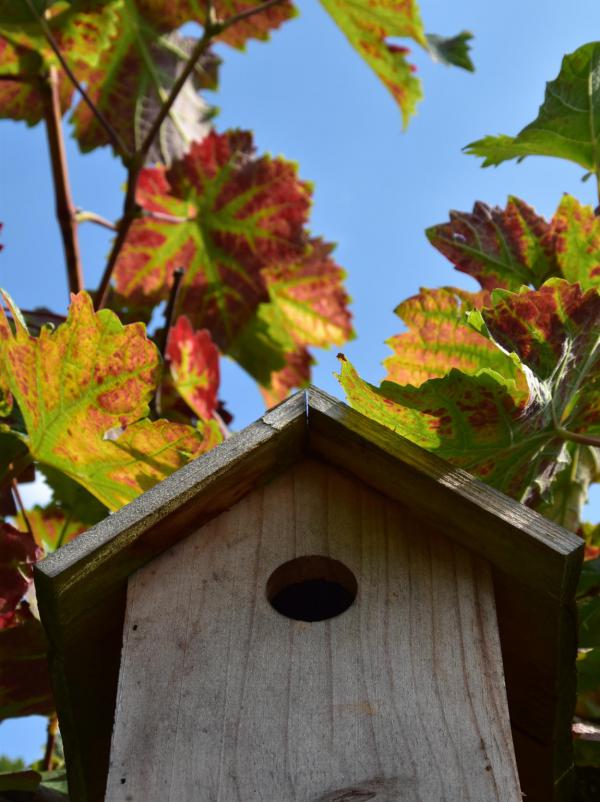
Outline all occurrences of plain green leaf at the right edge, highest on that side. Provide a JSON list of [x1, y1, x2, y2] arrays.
[[465, 42, 600, 173]]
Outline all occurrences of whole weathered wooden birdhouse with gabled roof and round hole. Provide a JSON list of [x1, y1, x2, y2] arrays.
[[36, 389, 582, 802]]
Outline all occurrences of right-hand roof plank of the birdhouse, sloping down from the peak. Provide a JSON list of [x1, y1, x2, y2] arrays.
[[308, 388, 583, 601]]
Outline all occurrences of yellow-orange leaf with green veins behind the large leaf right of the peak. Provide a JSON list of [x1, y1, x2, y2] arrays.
[[384, 287, 522, 385]]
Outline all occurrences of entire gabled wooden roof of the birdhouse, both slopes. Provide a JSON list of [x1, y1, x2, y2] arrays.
[[35, 388, 583, 802]]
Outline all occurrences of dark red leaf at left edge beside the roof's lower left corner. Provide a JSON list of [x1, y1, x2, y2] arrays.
[[0, 521, 42, 616]]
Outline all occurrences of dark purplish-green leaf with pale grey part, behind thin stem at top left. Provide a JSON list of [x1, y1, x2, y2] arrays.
[[71, 2, 219, 164]]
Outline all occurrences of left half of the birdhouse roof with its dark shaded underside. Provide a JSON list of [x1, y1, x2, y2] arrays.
[[35, 394, 306, 802]]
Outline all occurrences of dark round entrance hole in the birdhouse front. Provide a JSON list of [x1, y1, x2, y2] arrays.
[[267, 555, 358, 621]]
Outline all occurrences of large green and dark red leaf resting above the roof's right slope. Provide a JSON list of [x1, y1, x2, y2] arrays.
[[339, 279, 600, 506]]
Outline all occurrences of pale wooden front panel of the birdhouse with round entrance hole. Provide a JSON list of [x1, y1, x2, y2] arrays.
[[106, 459, 521, 802]]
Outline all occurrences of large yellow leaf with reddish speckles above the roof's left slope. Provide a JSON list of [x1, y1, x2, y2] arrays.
[[0, 293, 220, 509]]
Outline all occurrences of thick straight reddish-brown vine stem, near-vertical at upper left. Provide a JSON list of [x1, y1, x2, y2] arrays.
[[42, 67, 83, 292]]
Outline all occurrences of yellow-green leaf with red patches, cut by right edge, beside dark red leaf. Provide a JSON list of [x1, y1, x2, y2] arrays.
[[550, 195, 600, 289]]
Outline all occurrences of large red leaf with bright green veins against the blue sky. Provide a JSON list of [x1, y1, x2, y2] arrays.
[[115, 131, 310, 352]]
